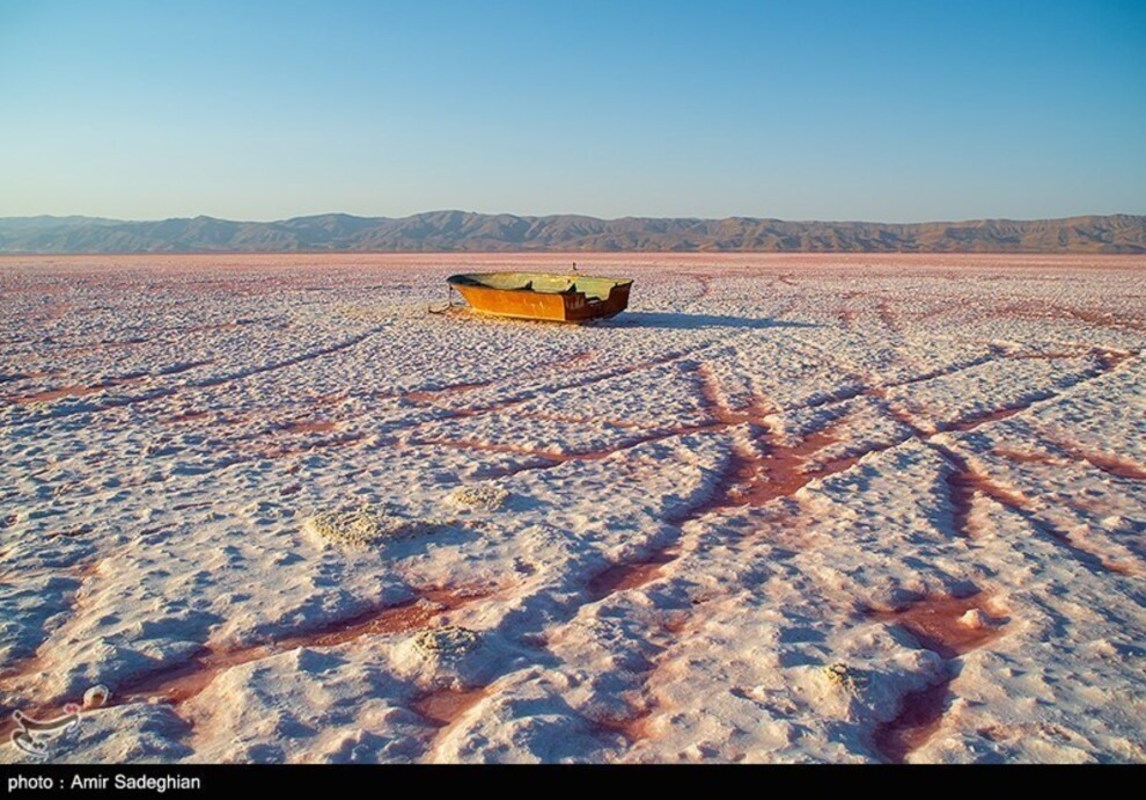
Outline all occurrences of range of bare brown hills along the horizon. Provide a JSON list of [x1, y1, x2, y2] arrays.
[[0, 211, 1146, 253]]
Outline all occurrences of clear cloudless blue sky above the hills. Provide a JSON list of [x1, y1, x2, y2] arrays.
[[0, 0, 1146, 221]]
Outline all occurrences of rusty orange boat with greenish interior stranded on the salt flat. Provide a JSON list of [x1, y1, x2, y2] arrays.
[[447, 273, 633, 322]]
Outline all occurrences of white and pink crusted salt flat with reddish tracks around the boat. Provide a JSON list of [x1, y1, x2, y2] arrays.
[[0, 254, 1146, 762]]
